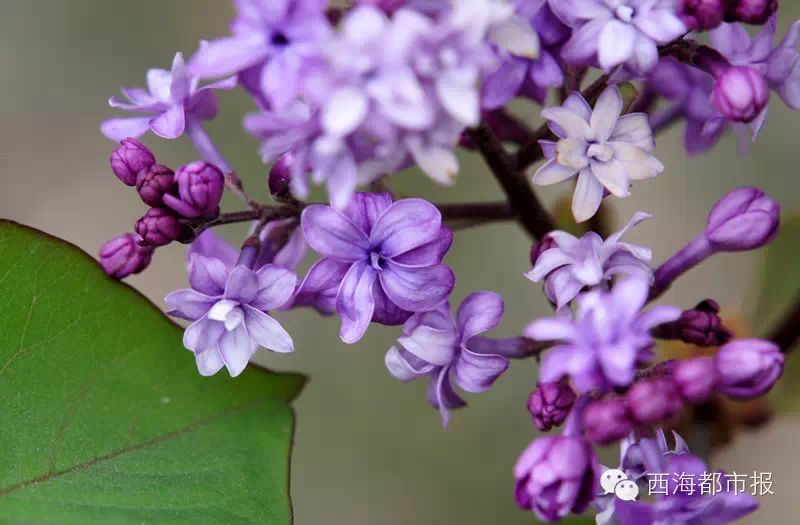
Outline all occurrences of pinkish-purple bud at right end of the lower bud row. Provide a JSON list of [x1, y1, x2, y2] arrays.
[[714, 339, 784, 400]]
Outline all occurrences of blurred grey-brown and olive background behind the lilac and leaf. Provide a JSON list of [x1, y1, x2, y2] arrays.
[[0, 0, 800, 525]]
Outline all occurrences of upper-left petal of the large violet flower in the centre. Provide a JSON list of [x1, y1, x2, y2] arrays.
[[301, 204, 369, 262]]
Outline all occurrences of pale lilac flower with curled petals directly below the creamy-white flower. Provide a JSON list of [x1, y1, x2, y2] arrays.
[[525, 212, 653, 309]]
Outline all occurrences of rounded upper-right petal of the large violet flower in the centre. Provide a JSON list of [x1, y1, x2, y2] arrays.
[[369, 199, 442, 258]]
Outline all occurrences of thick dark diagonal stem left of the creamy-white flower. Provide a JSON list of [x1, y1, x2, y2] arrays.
[[468, 125, 554, 239]]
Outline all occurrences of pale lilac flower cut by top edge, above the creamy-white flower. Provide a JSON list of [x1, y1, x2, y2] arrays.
[[550, 0, 687, 73]]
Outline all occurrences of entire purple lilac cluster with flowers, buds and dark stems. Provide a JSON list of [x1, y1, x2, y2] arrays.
[[95, 0, 800, 525]]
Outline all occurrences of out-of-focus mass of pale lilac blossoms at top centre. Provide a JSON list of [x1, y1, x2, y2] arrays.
[[245, 4, 494, 209]]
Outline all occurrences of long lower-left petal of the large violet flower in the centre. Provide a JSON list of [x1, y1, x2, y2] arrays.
[[336, 261, 377, 344]]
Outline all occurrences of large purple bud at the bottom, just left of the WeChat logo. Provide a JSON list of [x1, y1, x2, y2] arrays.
[[514, 436, 600, 522]]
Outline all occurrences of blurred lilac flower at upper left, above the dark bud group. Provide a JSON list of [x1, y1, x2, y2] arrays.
[[100, 53, 236, 141]]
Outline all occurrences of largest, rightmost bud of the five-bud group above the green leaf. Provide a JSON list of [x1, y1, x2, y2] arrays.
[[164, 160, 225, 219]]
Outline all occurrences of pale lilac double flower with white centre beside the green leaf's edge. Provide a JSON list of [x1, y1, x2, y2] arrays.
[[165, 253, 297, 377]]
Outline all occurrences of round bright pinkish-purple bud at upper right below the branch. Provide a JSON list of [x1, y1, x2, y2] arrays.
[[711, 66, 769, 122]]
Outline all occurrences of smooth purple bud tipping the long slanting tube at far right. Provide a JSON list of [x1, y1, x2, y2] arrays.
[[705, 188, 780, 252]]
